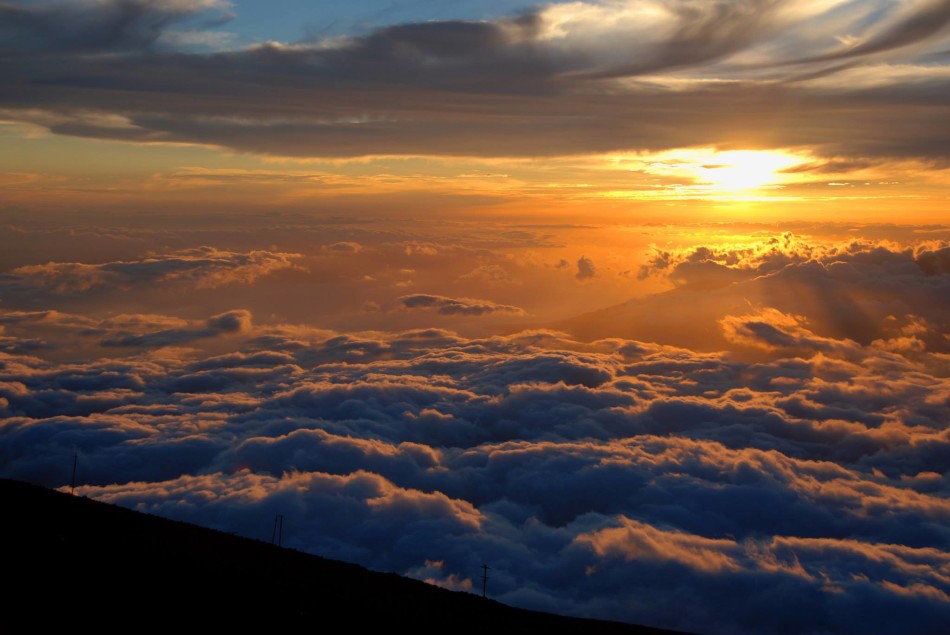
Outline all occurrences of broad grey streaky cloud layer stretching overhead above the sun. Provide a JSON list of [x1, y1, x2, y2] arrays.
[[0, 0, 950, 160]]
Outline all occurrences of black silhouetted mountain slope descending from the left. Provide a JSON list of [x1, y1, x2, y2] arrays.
[[0, 479, 696, 635]]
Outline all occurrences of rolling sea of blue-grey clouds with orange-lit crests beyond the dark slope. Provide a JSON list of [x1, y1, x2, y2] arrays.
[[0, 234, 950, 635]]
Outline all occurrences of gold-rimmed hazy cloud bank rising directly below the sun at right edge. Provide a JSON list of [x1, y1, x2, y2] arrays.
[[557, 232, 950, 353]]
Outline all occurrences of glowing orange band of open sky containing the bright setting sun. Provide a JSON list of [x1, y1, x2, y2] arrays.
[[0, 123, 950, 223]]
